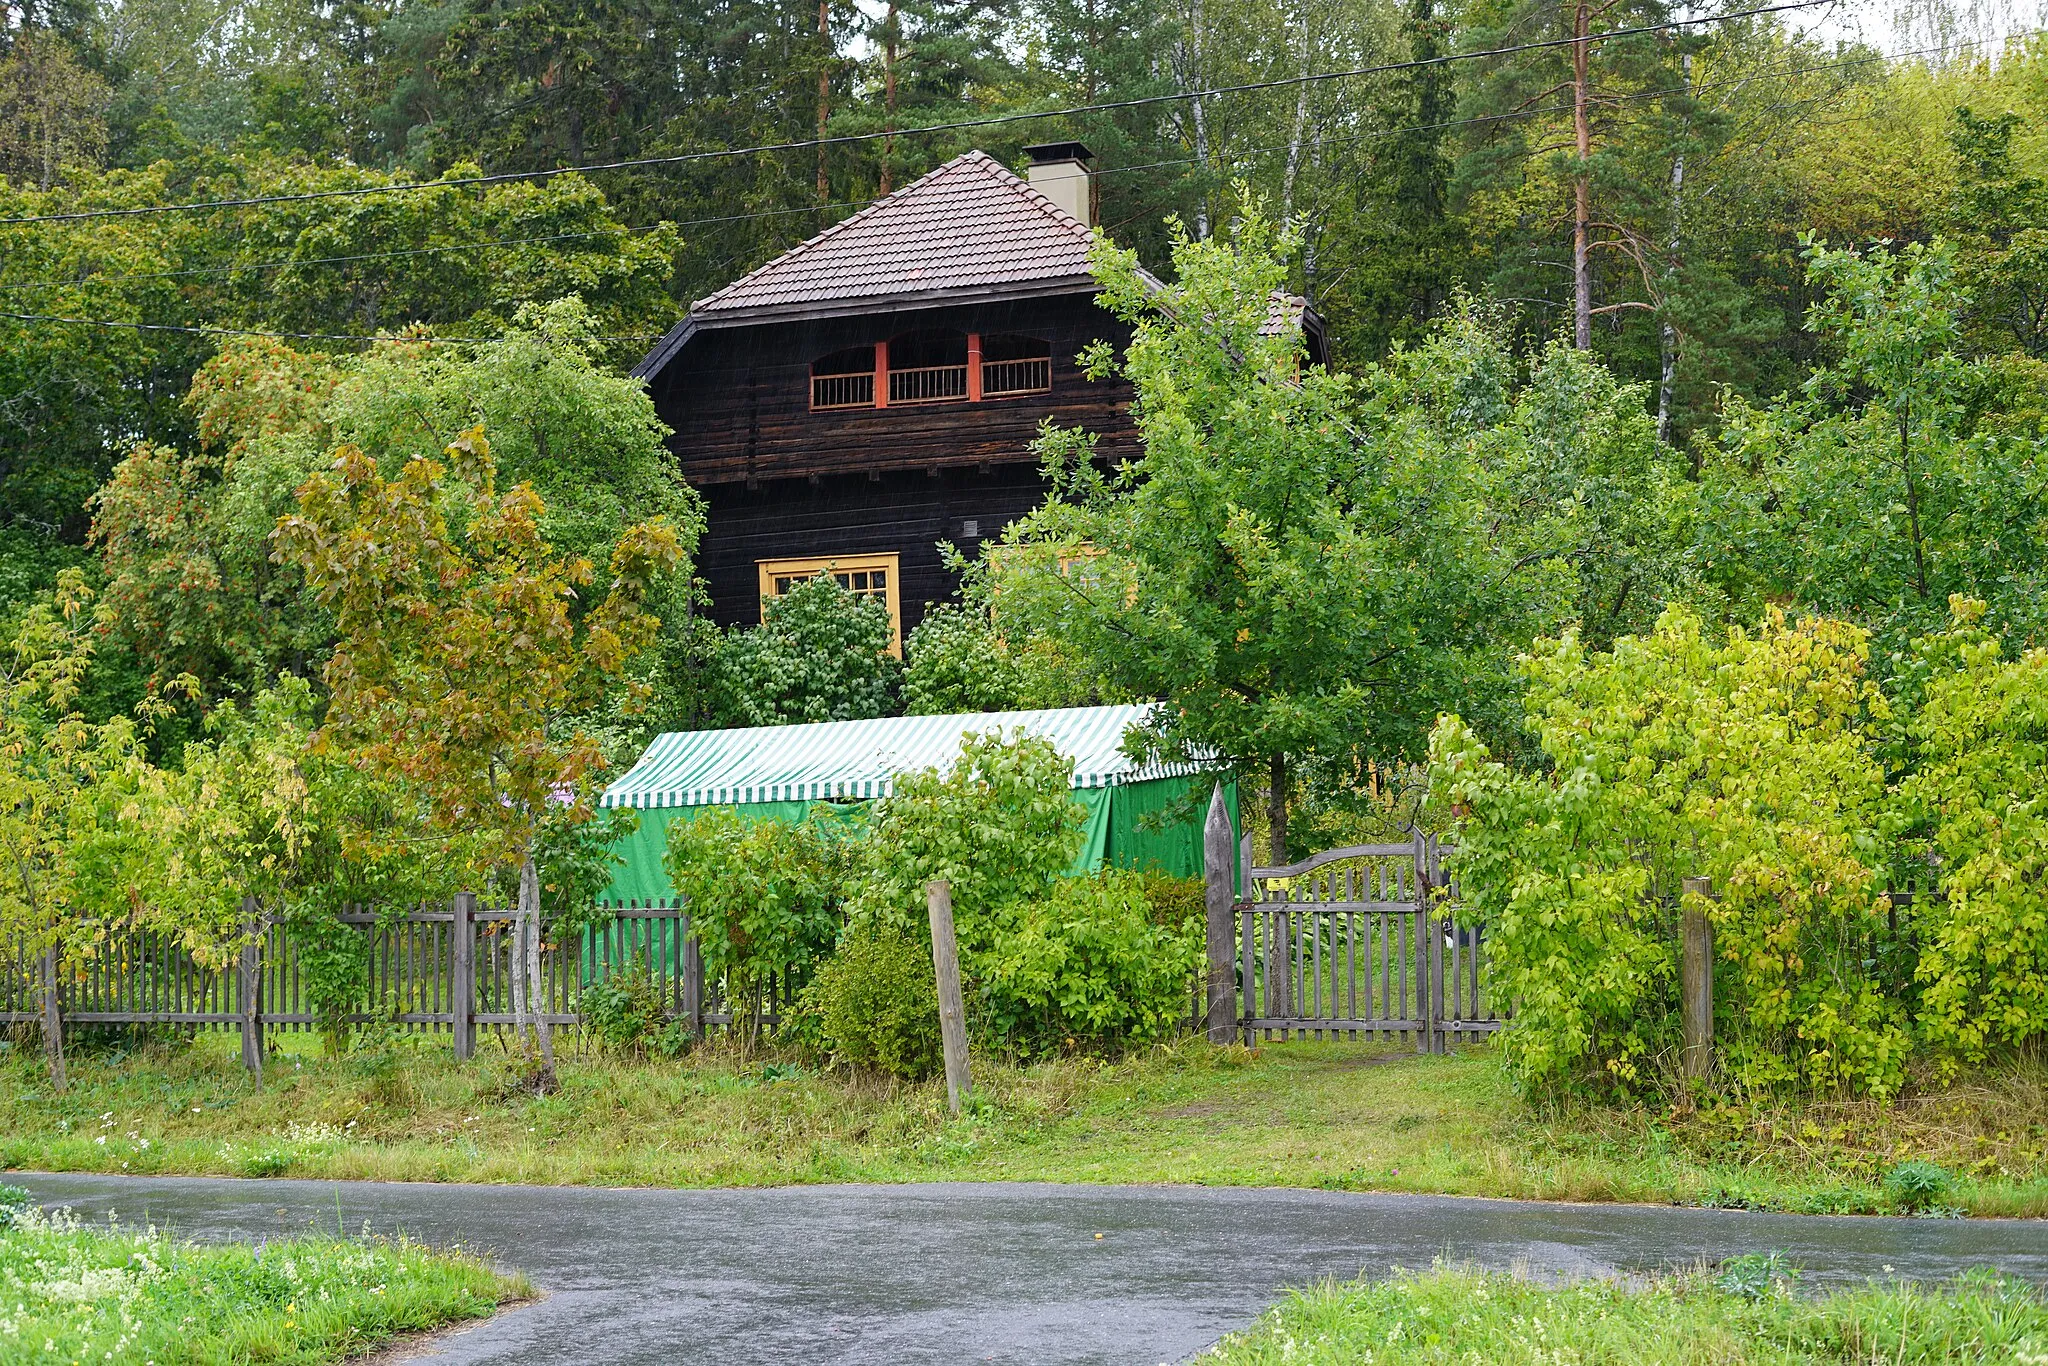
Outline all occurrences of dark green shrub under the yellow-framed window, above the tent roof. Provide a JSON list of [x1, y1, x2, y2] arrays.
[[719, 573, 903, 725]]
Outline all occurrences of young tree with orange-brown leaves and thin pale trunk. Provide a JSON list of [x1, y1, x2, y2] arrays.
[[276, 428, 682, 1087]]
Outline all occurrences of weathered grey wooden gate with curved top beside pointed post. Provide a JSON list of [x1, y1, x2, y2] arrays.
[[1235, 836, 1505, 1053]]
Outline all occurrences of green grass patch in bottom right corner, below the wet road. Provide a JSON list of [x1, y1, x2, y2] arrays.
[[1200, 1268, 2048, 1366]]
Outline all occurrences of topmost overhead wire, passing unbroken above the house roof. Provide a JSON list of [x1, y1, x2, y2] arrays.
[[0, 0, 1839, 227]]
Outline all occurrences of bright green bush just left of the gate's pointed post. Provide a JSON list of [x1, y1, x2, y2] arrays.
[[971, 868, 1202, 1055]]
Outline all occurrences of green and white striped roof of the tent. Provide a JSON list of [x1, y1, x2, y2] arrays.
[[598, 705, 1200, 811]]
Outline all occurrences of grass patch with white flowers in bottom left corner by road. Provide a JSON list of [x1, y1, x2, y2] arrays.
[[0, 1188, 526, 1366]]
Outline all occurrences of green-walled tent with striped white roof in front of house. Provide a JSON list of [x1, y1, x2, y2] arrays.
[[600, 707, 1237, 901]]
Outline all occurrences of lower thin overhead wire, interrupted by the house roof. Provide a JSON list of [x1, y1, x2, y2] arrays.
[[0, 29, 1925, 305]]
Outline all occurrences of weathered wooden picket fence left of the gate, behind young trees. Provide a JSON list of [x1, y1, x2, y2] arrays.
[[0, 895, 795, 1067]]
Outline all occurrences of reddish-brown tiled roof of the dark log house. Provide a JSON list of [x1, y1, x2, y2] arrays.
[[690, 152, 1092, 326]]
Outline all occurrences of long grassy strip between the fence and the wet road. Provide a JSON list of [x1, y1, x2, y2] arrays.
[[0, 1036, 2048, 1216]]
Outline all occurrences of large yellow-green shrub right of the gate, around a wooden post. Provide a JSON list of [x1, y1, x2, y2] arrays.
[[1430, 608, 1911, 1096]]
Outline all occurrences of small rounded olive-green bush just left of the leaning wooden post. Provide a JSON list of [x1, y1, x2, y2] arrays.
[[805, 934, 942, 1081]]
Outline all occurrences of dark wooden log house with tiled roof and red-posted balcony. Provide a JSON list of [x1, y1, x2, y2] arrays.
[[633, 143, 1323, 641]]
